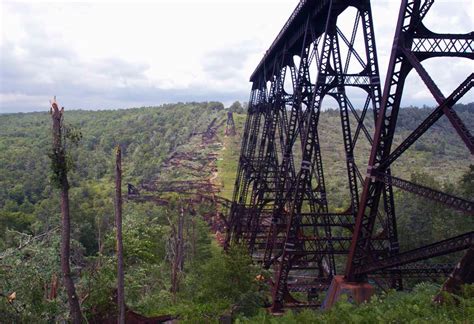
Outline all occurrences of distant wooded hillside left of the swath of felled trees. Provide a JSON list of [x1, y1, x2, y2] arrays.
[[0, 103, 224, 246]]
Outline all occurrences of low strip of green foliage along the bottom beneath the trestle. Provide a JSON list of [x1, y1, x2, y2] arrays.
[[241, 284, 474, 324]]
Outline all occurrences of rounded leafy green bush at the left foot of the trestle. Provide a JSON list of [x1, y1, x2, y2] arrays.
[[159, 246, 266, 323]]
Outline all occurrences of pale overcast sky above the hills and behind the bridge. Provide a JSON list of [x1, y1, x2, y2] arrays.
[[0, 0, 474, 113]]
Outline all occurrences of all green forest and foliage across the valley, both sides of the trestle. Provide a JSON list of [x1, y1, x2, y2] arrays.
[[0, 102, 474, 323]]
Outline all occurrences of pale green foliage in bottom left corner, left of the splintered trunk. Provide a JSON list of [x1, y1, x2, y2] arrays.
[[0, 231, 68, 323]]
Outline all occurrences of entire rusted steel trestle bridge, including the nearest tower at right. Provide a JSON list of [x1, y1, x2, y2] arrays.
[[227, 0, 473, 312]]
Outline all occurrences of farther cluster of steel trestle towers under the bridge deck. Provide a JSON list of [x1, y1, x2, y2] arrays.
[[228, 0, 406, 311]]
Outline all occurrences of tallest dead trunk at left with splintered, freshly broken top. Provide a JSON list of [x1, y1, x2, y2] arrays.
[[51, 98, 82, 323]]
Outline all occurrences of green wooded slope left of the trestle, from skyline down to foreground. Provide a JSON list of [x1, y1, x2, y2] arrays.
[[0, 102, 266, 322]]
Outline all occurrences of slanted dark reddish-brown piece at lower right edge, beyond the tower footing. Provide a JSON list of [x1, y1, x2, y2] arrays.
[[434, 247, 474, 303]]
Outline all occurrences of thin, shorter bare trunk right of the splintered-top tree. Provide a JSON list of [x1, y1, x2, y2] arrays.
[[115, 145, 125, 324]]
